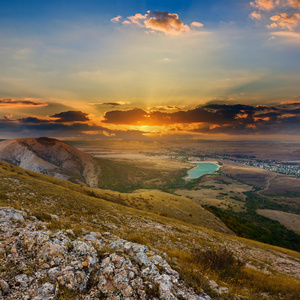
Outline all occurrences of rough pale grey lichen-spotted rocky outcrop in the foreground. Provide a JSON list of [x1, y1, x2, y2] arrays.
[[0, 207, 211, 300]]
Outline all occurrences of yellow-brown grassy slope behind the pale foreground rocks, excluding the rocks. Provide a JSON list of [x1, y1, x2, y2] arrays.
[[0, 163, 300, 299]]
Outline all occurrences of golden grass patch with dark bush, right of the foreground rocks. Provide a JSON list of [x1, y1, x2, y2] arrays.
[[167, 248, 300, 300]]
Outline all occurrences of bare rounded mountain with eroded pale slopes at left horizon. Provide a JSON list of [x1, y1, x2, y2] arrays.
[[0, 137, 101, 187]]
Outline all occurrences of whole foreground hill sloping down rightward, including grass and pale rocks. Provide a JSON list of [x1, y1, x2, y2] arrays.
[[0, 163, 300, 299]]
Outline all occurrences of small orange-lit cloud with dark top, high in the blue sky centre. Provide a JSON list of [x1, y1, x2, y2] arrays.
[[123, 11, 198, 34]]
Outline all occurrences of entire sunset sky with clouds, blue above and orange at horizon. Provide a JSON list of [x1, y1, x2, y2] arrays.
[[0, 0, 300, 140]]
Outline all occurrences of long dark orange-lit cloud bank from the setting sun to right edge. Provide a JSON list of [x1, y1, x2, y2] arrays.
[[104, 103, 300, 134]]
